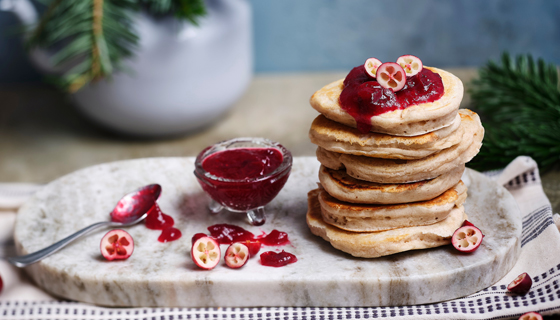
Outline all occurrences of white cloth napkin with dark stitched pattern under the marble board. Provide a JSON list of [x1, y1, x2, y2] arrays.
[[0, 157, 560, 320]]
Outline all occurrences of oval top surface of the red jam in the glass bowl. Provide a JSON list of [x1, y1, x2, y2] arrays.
[[202, 148, 283, 180]]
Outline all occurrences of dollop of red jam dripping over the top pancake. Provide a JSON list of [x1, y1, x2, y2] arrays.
[[339, 65, 444, 133]]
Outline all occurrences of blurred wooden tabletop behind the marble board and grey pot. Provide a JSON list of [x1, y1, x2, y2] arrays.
[[0, 69, 560, 212]]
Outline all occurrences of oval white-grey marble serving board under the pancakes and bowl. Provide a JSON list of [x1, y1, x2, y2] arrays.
[[15, 158, 521, 307]]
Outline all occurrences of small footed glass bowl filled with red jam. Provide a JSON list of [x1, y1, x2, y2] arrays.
[[194, 138, 292, 226]]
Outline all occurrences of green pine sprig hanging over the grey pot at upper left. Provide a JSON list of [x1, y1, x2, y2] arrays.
[[27, 0, 206, 92]]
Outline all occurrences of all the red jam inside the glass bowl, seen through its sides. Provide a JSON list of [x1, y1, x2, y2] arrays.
[[195, 148, 291, 211]]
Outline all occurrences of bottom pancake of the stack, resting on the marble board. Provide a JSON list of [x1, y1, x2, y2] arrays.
[[306, 189, 467, 258]]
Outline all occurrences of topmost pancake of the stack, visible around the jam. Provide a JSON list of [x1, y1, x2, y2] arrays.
[[310, 67, 463, 136]]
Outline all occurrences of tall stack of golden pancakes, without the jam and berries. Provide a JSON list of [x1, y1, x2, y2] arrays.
[[307, 68, 484, 258]]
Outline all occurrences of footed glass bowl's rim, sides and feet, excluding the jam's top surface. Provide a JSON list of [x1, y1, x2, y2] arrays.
[[194, 138, 292, 225]]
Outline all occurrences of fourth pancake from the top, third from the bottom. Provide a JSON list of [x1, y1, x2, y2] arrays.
[[319, 164, 465, 204]]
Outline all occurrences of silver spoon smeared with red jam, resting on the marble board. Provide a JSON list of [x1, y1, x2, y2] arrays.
[[7, 184, 161, 268]]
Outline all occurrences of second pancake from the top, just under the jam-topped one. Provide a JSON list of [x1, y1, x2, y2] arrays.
[[309, 110, 465, 160]]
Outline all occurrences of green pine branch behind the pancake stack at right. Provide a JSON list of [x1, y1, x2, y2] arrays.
[[469, 53, 560, 170]]
